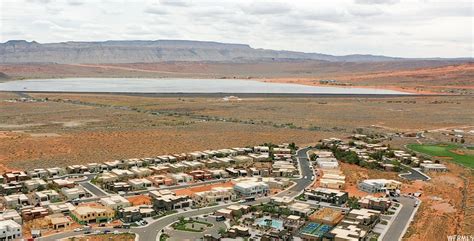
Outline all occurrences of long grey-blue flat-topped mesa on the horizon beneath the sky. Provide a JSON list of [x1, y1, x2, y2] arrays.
[[0, 40, 408, 64]]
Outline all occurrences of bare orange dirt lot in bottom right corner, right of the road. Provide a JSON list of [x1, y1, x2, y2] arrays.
[[404, 163, 474, 241]]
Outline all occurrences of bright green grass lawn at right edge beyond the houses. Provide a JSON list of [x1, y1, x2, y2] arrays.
[[407, 144, 474, 168]]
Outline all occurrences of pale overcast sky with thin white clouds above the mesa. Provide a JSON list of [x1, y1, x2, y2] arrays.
[[0, 0, 474, 57]]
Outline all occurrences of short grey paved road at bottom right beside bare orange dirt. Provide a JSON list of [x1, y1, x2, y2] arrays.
[[382, 197, 416, 241]]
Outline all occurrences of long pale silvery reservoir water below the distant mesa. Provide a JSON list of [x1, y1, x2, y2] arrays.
[[0, 78, 408, 95]]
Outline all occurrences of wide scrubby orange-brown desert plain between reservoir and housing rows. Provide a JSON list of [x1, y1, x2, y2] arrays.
[[0, 94, 474, 168]]
